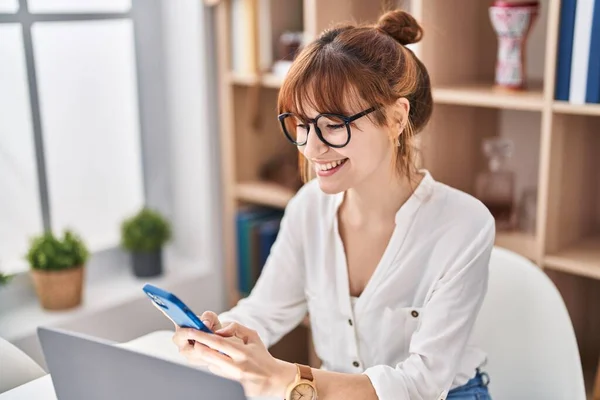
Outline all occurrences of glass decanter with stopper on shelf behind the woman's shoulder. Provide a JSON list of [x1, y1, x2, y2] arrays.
[[475, 137, 515, 230]]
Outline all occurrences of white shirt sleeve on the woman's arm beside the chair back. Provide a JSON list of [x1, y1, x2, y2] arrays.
[[364, 218, 495, 400]]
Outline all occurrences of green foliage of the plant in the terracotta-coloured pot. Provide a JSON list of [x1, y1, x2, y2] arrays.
[[26, 230, 89, 271]]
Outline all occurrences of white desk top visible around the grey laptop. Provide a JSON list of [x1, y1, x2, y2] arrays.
[[0, 331, 280, 400]]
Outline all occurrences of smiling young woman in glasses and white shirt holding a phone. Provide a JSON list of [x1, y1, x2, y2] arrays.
[[174, 7, 495, 400]]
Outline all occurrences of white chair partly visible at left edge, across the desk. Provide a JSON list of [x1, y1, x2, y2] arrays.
[[0, 337, 46, 393]]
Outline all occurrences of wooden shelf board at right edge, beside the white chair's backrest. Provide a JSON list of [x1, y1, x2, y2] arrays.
[[544, 236, 600, 279]]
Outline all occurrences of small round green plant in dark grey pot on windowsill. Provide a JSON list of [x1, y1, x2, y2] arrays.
[[121, 207, 171, 277]]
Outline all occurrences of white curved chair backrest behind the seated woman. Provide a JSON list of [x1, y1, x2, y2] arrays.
[[473, 247, 586, 400]]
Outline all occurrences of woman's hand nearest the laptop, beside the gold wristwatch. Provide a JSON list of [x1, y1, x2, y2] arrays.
[[178, 322, 296, 397]]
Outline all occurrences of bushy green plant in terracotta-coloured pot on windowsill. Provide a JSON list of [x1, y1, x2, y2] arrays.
[[26, 230, 89, 310]]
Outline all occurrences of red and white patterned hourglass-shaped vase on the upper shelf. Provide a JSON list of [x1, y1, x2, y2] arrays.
[[489, 0, 540, 90]]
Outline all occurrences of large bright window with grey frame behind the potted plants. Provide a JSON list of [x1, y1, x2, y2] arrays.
[[0, 0, 144, 273]]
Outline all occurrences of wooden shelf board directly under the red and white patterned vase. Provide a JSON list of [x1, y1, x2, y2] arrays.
[[433, 83, 544, 111]]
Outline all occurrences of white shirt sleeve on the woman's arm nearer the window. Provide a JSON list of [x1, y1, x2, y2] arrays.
[[219, 195, 307, 347]]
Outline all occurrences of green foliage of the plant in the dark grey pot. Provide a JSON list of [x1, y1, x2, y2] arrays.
[[121, 207, 171, 252]]
